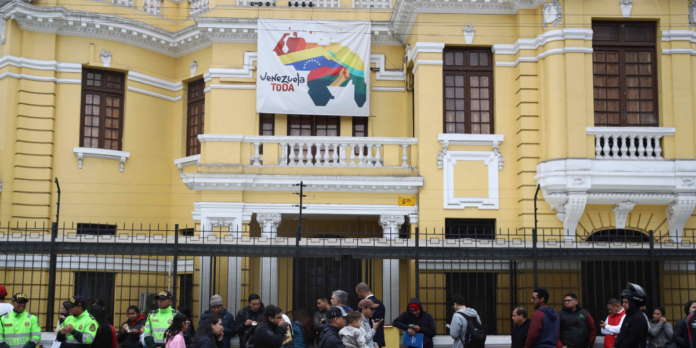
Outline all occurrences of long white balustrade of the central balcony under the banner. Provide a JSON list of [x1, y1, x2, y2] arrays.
[[242, 136, 418, 168]]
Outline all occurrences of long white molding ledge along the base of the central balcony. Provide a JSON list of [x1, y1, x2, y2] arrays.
[[181, 173, 422, 194]]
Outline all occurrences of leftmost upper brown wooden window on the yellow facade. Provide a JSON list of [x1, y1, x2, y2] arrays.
[[80, 69, 125, 150]]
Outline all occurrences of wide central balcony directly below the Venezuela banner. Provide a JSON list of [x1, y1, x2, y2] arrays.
[[174, 134, 423, 193]]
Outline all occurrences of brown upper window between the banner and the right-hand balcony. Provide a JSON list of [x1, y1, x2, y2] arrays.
[[443, 47, 494, 134]]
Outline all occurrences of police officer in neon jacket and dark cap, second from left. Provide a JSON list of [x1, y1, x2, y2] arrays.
[[56, 295, 99, 348]]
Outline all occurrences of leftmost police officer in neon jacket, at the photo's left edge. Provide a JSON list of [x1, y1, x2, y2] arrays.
[[0, 292, 41, 348]]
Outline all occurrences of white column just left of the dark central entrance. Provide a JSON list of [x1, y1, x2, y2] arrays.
[[256, 213, 282, 305]]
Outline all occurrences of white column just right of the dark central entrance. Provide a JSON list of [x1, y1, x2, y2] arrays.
[[379, 215, 405, 323]]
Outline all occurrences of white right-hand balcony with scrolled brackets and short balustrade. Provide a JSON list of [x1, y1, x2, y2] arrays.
[[535, 127, 696, 242]]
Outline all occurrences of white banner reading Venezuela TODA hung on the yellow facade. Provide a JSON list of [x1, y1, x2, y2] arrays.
[[256, 18, 371, 116]]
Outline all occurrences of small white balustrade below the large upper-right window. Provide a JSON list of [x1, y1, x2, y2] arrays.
[[587, 127, 675, 160]]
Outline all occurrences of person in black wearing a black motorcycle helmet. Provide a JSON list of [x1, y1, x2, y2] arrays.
[[614, 283, 648, 348]]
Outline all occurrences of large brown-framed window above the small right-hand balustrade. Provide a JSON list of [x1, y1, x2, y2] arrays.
[[592, 22, 659, 127]]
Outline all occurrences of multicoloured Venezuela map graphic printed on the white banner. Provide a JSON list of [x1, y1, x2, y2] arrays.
[[273, 33, 367, 107]]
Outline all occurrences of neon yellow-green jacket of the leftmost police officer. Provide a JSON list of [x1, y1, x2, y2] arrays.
[[0, 311, 41, 348]]
